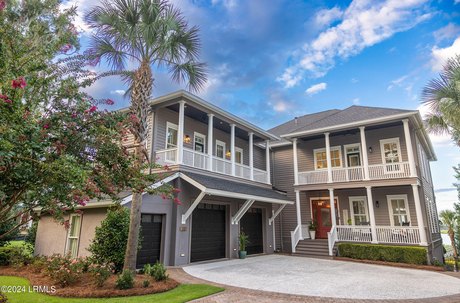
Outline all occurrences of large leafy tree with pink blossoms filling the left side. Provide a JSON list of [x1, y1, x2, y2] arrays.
[[0, 0, 178, 241]]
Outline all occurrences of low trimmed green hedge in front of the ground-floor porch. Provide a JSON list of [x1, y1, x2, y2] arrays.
[[338, 243, 427, 265]]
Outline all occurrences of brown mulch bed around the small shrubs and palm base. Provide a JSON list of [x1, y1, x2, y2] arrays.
[[0, 267, 179, 298]]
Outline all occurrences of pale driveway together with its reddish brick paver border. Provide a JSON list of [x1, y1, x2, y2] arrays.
[[169, 255, 460, 303]]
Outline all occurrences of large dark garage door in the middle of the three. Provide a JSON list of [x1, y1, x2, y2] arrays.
[[190, 203, 226, 262]]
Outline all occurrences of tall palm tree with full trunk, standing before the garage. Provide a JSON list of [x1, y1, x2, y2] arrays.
[[85, 0, 206, 271]]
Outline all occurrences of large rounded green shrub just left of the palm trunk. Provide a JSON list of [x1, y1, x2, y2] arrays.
[[88, 206, 129, 272]]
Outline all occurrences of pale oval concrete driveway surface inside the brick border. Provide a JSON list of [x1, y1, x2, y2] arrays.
[[183, 255, 460, 299]]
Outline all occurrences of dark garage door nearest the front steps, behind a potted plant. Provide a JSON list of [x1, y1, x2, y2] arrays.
[[240, 208, 264, 255]]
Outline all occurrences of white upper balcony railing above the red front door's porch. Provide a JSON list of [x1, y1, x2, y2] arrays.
[[299, 162, 410, 184]]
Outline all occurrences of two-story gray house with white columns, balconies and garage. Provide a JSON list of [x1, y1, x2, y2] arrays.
[[36, 91, 442, 266]]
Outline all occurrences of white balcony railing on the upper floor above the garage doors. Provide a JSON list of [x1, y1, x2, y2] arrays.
[[155, 147, 268, 183]]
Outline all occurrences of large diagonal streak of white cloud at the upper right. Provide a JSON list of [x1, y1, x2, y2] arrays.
[[278, 0, 431, 86]]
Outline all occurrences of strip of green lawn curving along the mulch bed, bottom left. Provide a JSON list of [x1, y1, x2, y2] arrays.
[[0, 276, 224, 303]]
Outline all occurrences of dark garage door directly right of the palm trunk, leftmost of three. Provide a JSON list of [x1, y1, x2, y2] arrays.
[[136, 214, 163, 268]]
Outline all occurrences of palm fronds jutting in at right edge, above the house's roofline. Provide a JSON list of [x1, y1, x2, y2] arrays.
[[422, 55, 460, 145]]
